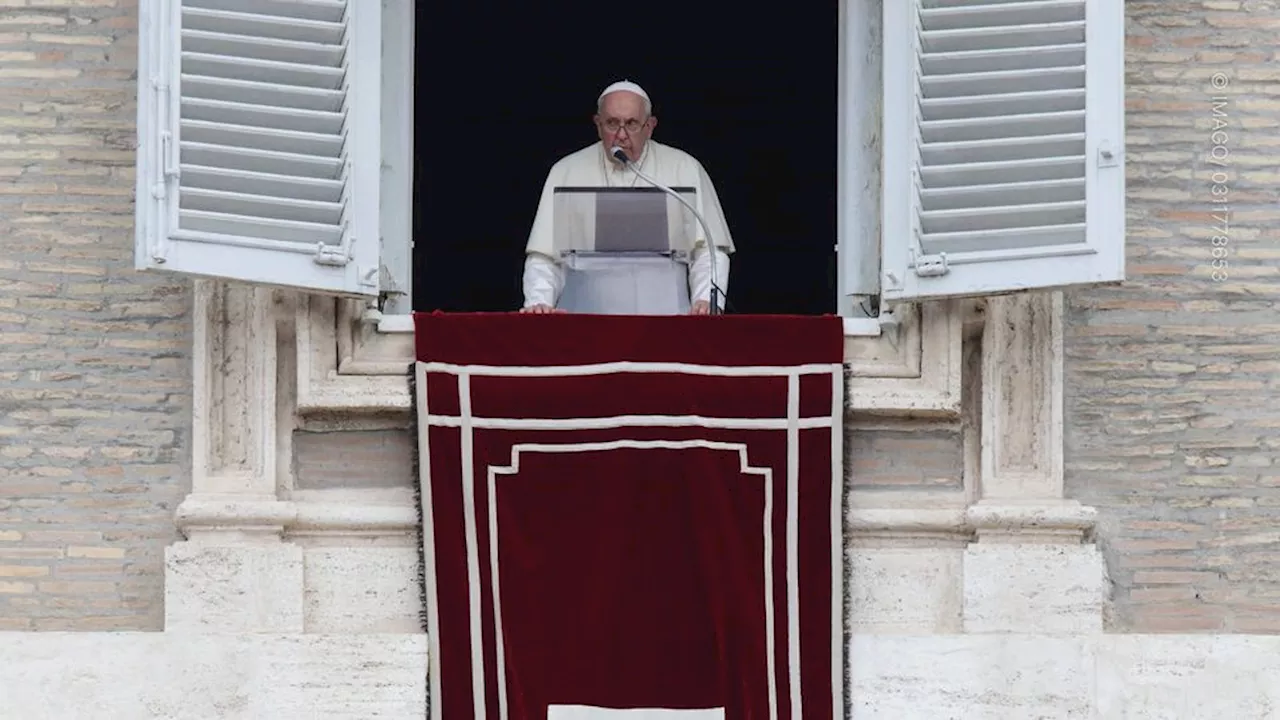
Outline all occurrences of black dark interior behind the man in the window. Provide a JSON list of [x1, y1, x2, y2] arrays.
[[413, 0, 838, 314]]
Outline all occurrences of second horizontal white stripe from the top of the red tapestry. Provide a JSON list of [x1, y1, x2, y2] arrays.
[[426, 415, 833, 430]]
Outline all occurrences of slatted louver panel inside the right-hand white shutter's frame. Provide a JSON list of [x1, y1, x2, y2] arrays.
[[919, 0, 1085, 255]]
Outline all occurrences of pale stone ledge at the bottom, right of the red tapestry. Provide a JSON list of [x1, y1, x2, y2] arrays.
[[849, 634, 1280, 720]]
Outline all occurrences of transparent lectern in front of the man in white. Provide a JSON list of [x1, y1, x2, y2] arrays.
[[552, 186, 698, 315]]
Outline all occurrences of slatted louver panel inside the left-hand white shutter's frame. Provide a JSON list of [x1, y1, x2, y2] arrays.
[[178, 0, 346, 246]]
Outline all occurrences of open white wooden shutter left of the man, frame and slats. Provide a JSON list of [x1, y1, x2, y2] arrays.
[[134, 0, 381, 296]]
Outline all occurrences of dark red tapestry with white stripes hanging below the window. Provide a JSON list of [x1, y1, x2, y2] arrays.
[[415, 314, 844, 720]]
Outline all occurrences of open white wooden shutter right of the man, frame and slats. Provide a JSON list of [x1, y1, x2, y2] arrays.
[[881, 0, 1124, 300]]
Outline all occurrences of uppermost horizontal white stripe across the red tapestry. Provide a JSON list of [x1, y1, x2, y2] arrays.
[[422, 360, 845, 378]]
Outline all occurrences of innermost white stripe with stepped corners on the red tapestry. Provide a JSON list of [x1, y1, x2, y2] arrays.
[[488, 439, 778, 720]]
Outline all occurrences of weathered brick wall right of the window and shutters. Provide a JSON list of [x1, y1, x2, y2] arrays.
[[1066, 0, 1280, 632]]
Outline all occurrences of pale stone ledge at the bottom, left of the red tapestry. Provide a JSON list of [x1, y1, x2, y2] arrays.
[[0, 632, 428, 720]]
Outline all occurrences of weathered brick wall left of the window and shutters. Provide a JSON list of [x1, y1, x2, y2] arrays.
[[0, 0, 191, 630]]
